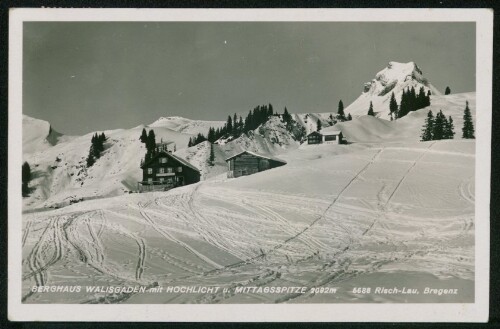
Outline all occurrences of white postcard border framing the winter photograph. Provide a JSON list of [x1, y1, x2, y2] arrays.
[[8, 9, 493, 322]]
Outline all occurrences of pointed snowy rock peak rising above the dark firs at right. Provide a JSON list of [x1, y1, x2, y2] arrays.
[[344, 62, 441, 120]]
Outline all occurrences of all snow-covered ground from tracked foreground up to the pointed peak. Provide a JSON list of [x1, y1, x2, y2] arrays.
[[22, 62, 476, 303]]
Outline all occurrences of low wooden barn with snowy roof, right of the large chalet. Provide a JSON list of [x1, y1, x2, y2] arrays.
[[226, 151, 286, 178]]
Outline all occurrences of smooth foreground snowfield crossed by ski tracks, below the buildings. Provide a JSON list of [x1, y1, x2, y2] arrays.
[[23, 141, 475, 303]]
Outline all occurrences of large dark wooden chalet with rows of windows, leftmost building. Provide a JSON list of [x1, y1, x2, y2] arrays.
[[138, 150, 201, 192]]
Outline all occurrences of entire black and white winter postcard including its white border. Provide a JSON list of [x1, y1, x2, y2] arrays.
[[9, 9, 493, 321]]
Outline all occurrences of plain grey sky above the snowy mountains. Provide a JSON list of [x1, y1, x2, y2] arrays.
[[23, 22, 476, 134]]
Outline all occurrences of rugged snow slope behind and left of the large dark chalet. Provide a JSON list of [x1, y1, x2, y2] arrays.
[[23, 116, 223, 208]]
